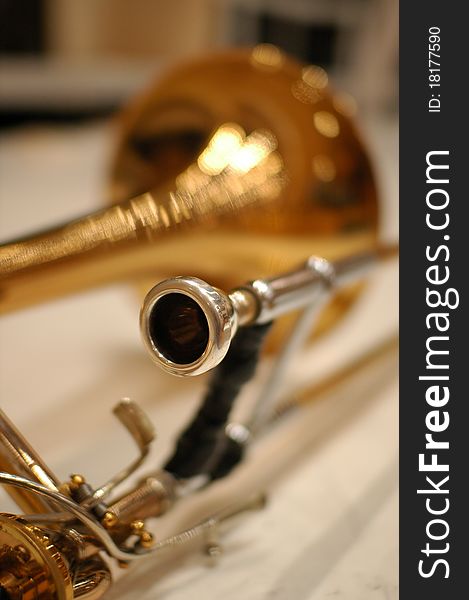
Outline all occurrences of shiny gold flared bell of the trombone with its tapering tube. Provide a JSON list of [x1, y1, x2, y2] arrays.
[[0, 46, 377, 336]]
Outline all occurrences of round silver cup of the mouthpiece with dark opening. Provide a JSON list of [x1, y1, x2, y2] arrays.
[[140, 277, 234, 376]]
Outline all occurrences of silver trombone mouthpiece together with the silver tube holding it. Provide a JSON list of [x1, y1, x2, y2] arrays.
[[140, 252, 378, 376]]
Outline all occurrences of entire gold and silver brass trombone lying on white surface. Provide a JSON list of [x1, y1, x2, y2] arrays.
[[0, 46, 396, 600]]
